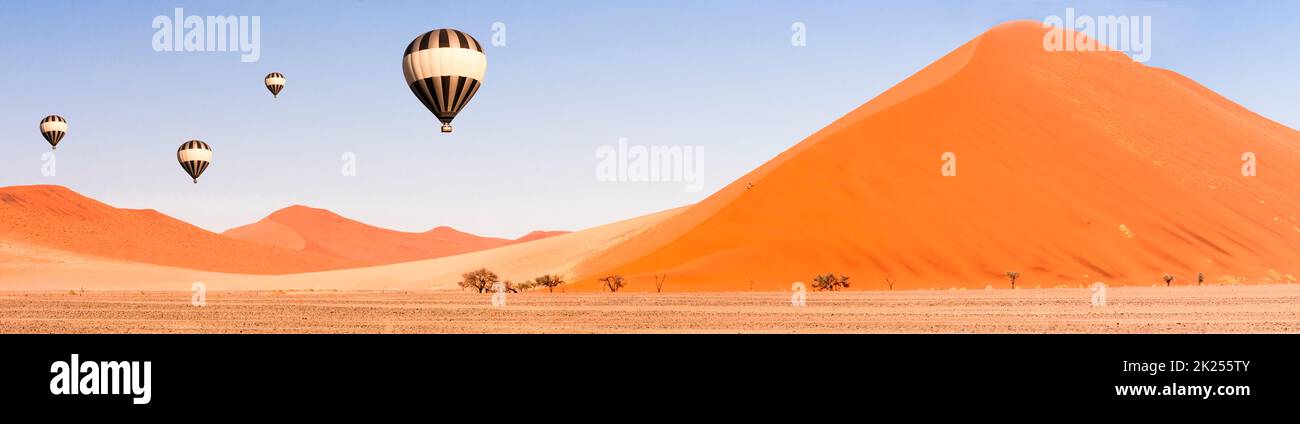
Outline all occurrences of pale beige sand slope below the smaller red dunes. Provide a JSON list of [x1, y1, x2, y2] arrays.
[[0, 204, 680, 290]]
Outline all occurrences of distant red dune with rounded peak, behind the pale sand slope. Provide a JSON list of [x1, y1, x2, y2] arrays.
[[222, 205, 566, 265]]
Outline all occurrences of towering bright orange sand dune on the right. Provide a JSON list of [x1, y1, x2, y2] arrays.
[[575, 21, 1300, 291]]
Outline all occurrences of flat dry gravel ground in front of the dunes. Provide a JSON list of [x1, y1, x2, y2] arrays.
[[0, 285, 1300, 333]]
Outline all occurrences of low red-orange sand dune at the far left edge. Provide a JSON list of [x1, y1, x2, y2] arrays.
[[0, 186, 360, 274]]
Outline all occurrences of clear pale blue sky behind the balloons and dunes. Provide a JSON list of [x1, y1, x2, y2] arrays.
[[0, 0, 1300, 237]]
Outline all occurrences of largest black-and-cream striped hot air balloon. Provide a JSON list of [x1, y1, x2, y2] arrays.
[[402, 29, 488, 133]]
